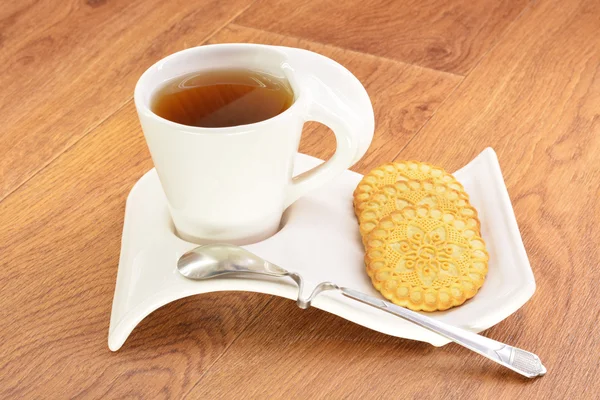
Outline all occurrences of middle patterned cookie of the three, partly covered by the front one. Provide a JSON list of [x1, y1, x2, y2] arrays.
[[358, 179, 479, 242]]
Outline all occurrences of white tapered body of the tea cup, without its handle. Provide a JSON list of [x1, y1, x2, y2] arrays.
[[134, 44, 307, 244]]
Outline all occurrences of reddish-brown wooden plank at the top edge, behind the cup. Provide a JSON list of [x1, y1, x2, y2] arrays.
[[235, 0, 527, 75]]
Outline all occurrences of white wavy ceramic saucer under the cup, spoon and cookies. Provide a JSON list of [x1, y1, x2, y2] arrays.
[[108, 148, 535, 351]]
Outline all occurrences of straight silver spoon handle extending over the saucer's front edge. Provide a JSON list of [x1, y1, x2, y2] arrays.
[[340, 288, 546, 378]]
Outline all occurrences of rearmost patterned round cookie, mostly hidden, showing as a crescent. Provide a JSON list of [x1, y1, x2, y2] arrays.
[[354, 161, 469, 216]]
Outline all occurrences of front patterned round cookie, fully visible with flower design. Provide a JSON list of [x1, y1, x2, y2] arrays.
[[365, 205, 489, 311]]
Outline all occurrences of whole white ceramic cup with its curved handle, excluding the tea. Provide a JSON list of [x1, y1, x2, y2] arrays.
[[134, 44, 374, 244]]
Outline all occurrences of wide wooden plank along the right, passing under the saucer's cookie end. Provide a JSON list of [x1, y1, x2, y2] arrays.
[[188, 1, 600, 399]]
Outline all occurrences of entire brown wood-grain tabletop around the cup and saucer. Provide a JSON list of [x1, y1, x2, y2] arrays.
[[0, 0, 600, 399]]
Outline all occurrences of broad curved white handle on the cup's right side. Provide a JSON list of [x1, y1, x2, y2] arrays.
[[285, 67, 375, 208]]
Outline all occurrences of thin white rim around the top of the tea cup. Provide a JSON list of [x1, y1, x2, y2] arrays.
[[133, 43, 303, 135]]
